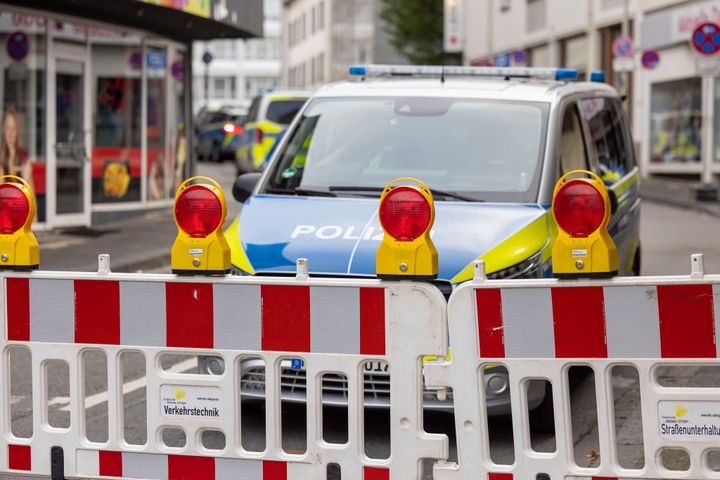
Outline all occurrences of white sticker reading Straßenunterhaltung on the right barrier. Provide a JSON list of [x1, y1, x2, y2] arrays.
[[658, 401, 720, 441]]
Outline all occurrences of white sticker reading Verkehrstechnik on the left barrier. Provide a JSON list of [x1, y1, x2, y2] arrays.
[[160, 385, 222, 420]]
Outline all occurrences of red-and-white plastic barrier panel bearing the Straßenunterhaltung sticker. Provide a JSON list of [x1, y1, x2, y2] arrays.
[[425, 259, 720, 480]]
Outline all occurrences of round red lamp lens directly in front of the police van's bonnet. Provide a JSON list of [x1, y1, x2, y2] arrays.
[[380, 186, 432, 242]]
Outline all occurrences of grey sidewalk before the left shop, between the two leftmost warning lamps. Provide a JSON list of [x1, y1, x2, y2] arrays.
[[36, 208, 177, 273]]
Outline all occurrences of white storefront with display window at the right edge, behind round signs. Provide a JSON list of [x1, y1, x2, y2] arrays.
[[634, 0, 720, 182]]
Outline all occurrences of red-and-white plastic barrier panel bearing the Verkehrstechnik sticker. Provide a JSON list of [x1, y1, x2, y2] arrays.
[[0, 272, 448, 480]]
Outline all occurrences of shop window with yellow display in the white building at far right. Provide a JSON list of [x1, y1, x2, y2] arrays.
[[650, 78, 702, 163]]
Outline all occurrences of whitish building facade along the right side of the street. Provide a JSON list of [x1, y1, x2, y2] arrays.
[[463, 0, 720, 182]]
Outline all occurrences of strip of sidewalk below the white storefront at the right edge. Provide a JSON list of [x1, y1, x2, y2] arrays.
[[640, 176, 720, 218]]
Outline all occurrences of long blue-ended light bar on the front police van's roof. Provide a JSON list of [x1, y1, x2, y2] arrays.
[[350, 65, 578, 80]]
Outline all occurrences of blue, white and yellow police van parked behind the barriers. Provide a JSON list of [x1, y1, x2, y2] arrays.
[[226, 66, 640, 413]]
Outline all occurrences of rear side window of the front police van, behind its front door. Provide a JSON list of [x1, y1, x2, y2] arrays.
[[579, 97, 633, 185]]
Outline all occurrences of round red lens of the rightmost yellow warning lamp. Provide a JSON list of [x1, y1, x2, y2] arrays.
[[553, 181, 605, 237]]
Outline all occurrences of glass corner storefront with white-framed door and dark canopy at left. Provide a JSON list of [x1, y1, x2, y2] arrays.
[[0, 0, 262, 228]]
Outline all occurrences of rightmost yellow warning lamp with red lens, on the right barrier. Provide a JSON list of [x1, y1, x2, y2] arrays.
[[552, 170, 618, 278]]
